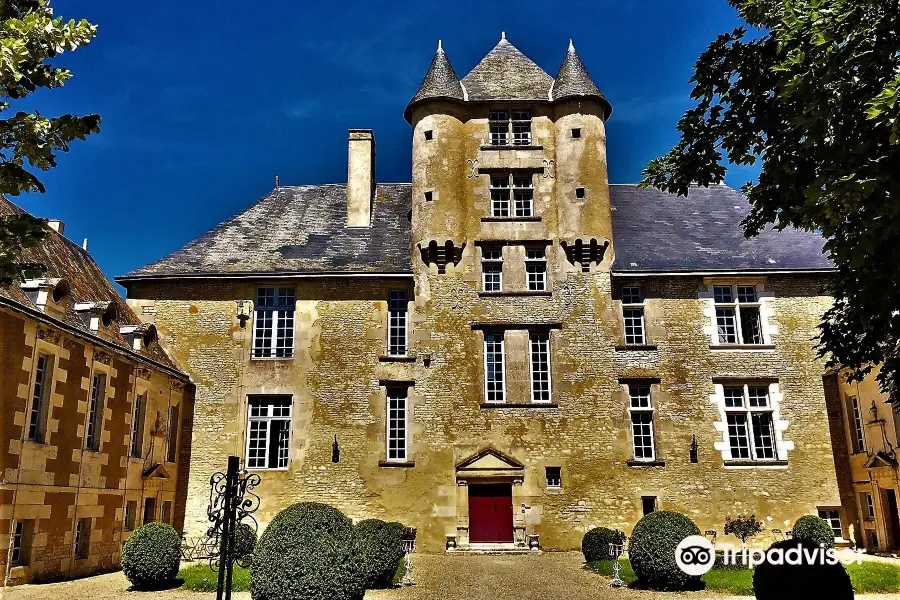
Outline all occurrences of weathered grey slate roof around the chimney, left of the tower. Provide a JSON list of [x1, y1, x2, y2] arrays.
[[116, 183, 412, 283]]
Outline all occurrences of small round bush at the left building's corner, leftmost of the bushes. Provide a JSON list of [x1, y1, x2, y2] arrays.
[[122, 523, 181, 589]]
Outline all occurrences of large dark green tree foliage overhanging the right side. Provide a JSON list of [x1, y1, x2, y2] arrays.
[[642, 0, 900, 406]]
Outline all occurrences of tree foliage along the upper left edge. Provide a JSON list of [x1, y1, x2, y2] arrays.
[[0, 0, 100, 285]]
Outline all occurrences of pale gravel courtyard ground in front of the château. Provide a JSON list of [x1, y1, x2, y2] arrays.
[[0, 552, 900, 600]]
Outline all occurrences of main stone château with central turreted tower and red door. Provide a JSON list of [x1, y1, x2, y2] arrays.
[[118, 36, 840, 551]]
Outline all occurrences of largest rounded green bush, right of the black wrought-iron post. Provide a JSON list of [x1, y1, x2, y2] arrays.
[[250, 502, 365, 600]]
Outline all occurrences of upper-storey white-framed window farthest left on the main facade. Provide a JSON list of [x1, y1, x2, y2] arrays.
[[253, 287, 297, 358]]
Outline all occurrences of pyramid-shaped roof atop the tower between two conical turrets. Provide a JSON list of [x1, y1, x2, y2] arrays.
[[462, 36, 553, 101]]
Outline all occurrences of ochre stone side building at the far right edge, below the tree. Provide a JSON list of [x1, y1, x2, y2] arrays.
[[825, 367, 900, 552]]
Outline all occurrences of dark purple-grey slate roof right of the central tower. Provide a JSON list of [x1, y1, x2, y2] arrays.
[[610, 185, 834, 273]]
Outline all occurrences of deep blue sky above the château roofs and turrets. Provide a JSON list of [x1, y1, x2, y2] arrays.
[[19, 0, 755, 288]]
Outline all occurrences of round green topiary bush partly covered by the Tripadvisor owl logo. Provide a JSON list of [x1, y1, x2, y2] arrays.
[[628, 510, 703, 590]]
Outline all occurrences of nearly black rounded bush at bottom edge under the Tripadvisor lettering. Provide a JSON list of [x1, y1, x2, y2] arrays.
[[753, 539, 853, 600]]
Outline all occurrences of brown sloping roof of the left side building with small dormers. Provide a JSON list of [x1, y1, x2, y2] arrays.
[[0, 196, 187, 380]]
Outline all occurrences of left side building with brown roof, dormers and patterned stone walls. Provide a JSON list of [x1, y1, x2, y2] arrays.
[[0, 197, 193, 586]]
